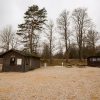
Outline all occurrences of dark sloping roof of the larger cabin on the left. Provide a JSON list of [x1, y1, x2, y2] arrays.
[[0, 49, 40, 58]]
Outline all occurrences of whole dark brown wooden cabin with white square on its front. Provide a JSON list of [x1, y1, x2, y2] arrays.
[[0, 49, 40, 72]]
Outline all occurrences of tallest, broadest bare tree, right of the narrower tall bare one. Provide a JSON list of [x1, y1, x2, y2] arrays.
[[72, 8, 90, 60]]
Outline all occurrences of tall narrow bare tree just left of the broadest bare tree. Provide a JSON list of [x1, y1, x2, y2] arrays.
[[57, 10, 70, 62]]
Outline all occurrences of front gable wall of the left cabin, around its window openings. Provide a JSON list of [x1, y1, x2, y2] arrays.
[[3, 51, 25, 71]]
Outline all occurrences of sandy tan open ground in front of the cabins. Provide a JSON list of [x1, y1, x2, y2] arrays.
[[0, 67, 100, 100]]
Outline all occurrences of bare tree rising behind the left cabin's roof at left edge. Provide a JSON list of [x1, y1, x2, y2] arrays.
[[0, 26, 17, 51]]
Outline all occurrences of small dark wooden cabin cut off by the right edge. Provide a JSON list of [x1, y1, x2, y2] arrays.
[[87, 56, 100, 67]]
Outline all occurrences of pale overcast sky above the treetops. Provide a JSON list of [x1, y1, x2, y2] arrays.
[[0, 0, 100, 31]]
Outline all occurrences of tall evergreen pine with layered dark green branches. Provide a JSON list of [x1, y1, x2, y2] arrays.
[[17, 5, 47, 53]]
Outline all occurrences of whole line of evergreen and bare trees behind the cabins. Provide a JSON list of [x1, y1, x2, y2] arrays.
[[0, 5, 100, 63]]
